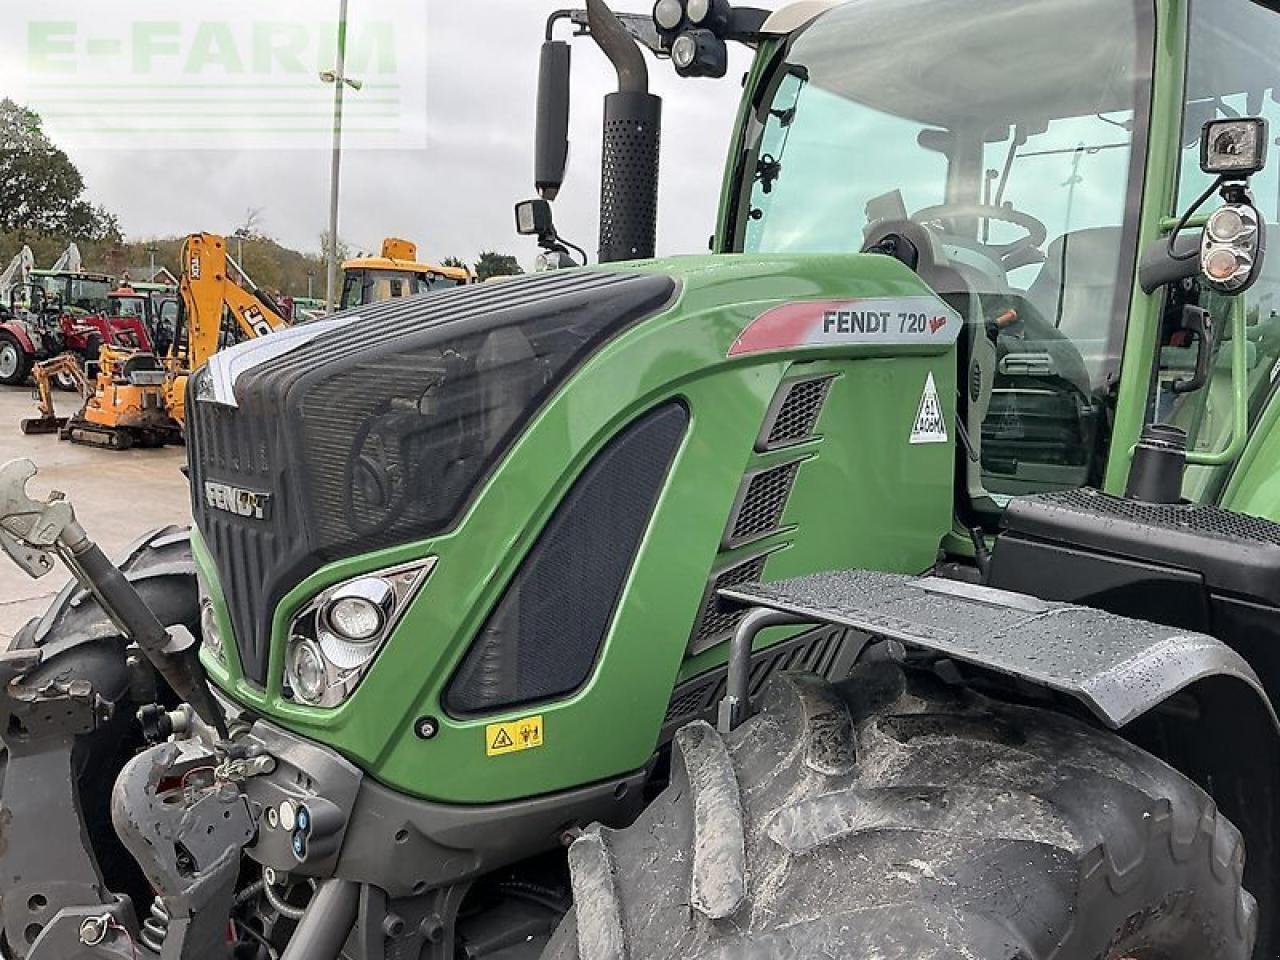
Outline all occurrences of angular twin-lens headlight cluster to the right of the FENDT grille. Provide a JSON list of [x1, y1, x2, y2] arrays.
[[284, 557, 435, 707]]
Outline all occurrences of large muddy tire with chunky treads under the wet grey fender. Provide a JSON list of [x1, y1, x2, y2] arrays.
[[544, 663, 1256, 960]]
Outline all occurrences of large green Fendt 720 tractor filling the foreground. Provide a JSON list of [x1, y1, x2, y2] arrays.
[[0, 0, 1280, 960]]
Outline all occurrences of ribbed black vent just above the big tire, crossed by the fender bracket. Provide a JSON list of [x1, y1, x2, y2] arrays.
[[662, 627, 867, 740]]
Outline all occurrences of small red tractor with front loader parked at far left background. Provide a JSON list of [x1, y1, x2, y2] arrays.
[[0, 270, 152, 389]]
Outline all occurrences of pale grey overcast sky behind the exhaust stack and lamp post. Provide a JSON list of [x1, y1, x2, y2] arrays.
[[0, 0, 774, 265]]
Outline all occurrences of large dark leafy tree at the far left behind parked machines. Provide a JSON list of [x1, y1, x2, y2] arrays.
[[0, 97, 120, 241]]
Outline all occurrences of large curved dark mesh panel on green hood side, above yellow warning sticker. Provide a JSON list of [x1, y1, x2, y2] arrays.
[[444, 403, 689, 714]]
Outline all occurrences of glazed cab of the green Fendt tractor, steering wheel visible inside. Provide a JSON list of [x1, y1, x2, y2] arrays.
[[724, 0, 1280, 512]]
